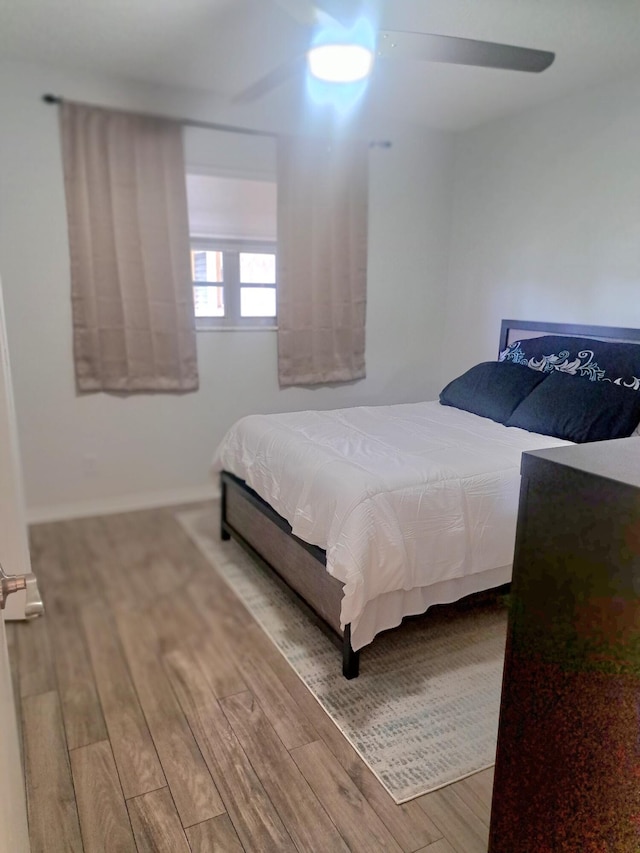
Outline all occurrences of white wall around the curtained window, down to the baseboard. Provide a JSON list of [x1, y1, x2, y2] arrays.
[[0, 58, 453, 519]]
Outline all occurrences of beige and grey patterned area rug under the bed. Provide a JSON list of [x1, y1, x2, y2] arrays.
[[177, 509, 507, 803]]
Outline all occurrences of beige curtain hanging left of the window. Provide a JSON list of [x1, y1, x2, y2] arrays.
[[60, 102, 198, 393]]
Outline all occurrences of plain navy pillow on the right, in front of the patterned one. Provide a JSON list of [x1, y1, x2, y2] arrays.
[[506, 371, 640, 443]]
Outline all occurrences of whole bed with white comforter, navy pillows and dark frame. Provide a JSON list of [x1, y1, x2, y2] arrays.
[[213, 320, 640, 678]]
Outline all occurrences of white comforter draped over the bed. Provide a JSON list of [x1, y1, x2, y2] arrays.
[[213, 402, 570, 649]]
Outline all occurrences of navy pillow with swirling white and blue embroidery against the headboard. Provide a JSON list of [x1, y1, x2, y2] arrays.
[[499, 335, 640, 391]]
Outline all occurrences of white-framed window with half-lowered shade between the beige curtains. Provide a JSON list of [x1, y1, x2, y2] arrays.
[[187, 175, 276, 329]]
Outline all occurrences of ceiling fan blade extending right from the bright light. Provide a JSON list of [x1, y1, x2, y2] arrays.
[[377, 30, 555, 72]]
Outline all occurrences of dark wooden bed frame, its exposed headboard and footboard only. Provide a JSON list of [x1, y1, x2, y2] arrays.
[[220, 320, 640, 678]]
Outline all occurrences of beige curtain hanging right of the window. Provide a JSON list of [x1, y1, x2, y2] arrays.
[[278, 138, 368, 386]]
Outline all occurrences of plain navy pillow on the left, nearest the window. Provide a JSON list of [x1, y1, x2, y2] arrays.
[[440, 361, 548, 424]]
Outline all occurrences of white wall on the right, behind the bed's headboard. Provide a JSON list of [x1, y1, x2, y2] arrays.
[[441, 70, 640, 382]]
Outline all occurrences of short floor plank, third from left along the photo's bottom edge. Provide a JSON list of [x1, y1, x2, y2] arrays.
[[127, 788, 190, 853]]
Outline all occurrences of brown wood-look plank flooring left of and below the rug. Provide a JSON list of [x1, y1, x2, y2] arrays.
[[7, 507, 493, 853]]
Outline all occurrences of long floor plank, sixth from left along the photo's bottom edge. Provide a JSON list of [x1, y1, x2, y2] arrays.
[[220, 691, 348, 853]]
